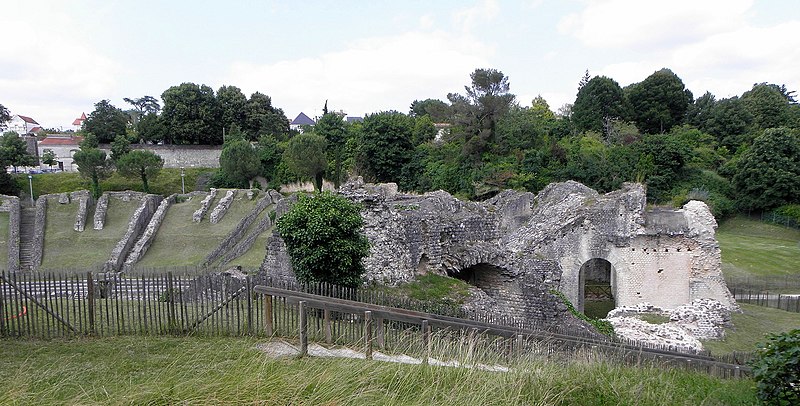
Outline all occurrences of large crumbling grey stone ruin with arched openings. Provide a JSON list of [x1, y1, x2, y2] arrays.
[[262, 179, 736, 332]]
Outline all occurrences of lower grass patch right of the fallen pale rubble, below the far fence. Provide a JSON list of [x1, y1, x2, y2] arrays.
[[703, 303, 800, 355]]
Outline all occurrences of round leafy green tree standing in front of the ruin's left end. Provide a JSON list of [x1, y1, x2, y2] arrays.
[[276, 192, 369, 287]]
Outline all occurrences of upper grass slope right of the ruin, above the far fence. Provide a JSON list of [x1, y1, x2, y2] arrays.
[[717, 217, 800, 278]]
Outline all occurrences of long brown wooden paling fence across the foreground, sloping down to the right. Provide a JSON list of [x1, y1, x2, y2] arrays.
[[0, 272, 748, 376]]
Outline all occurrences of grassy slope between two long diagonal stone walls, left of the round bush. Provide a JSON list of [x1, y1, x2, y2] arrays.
[[137, 189, 263, 268]]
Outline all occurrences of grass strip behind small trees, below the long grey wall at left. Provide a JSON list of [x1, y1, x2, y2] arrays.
[[21, 168, 214, 196]]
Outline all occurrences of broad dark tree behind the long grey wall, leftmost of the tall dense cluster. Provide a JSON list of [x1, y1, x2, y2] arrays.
[[161, 83, 222, 145]]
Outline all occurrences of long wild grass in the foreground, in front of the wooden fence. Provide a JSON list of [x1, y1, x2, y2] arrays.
[[0, 336, 756, 405]]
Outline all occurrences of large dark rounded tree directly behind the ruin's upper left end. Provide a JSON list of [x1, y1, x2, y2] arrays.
[[356, 111, 414, 182]]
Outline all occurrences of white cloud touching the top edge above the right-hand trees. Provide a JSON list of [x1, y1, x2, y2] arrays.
[[559, 0, 753, 51]]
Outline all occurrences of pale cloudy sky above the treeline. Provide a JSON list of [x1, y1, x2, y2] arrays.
[[0, 0, 800, 130]]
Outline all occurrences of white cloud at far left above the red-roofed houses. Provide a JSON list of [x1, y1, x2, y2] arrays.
[[0, 2, 119, 128]]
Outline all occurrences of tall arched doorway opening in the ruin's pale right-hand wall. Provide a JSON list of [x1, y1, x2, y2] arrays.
[[577, 258, 616, 318]]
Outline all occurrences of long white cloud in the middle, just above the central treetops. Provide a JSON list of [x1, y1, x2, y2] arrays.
[[224, 32, 491, 119]]
